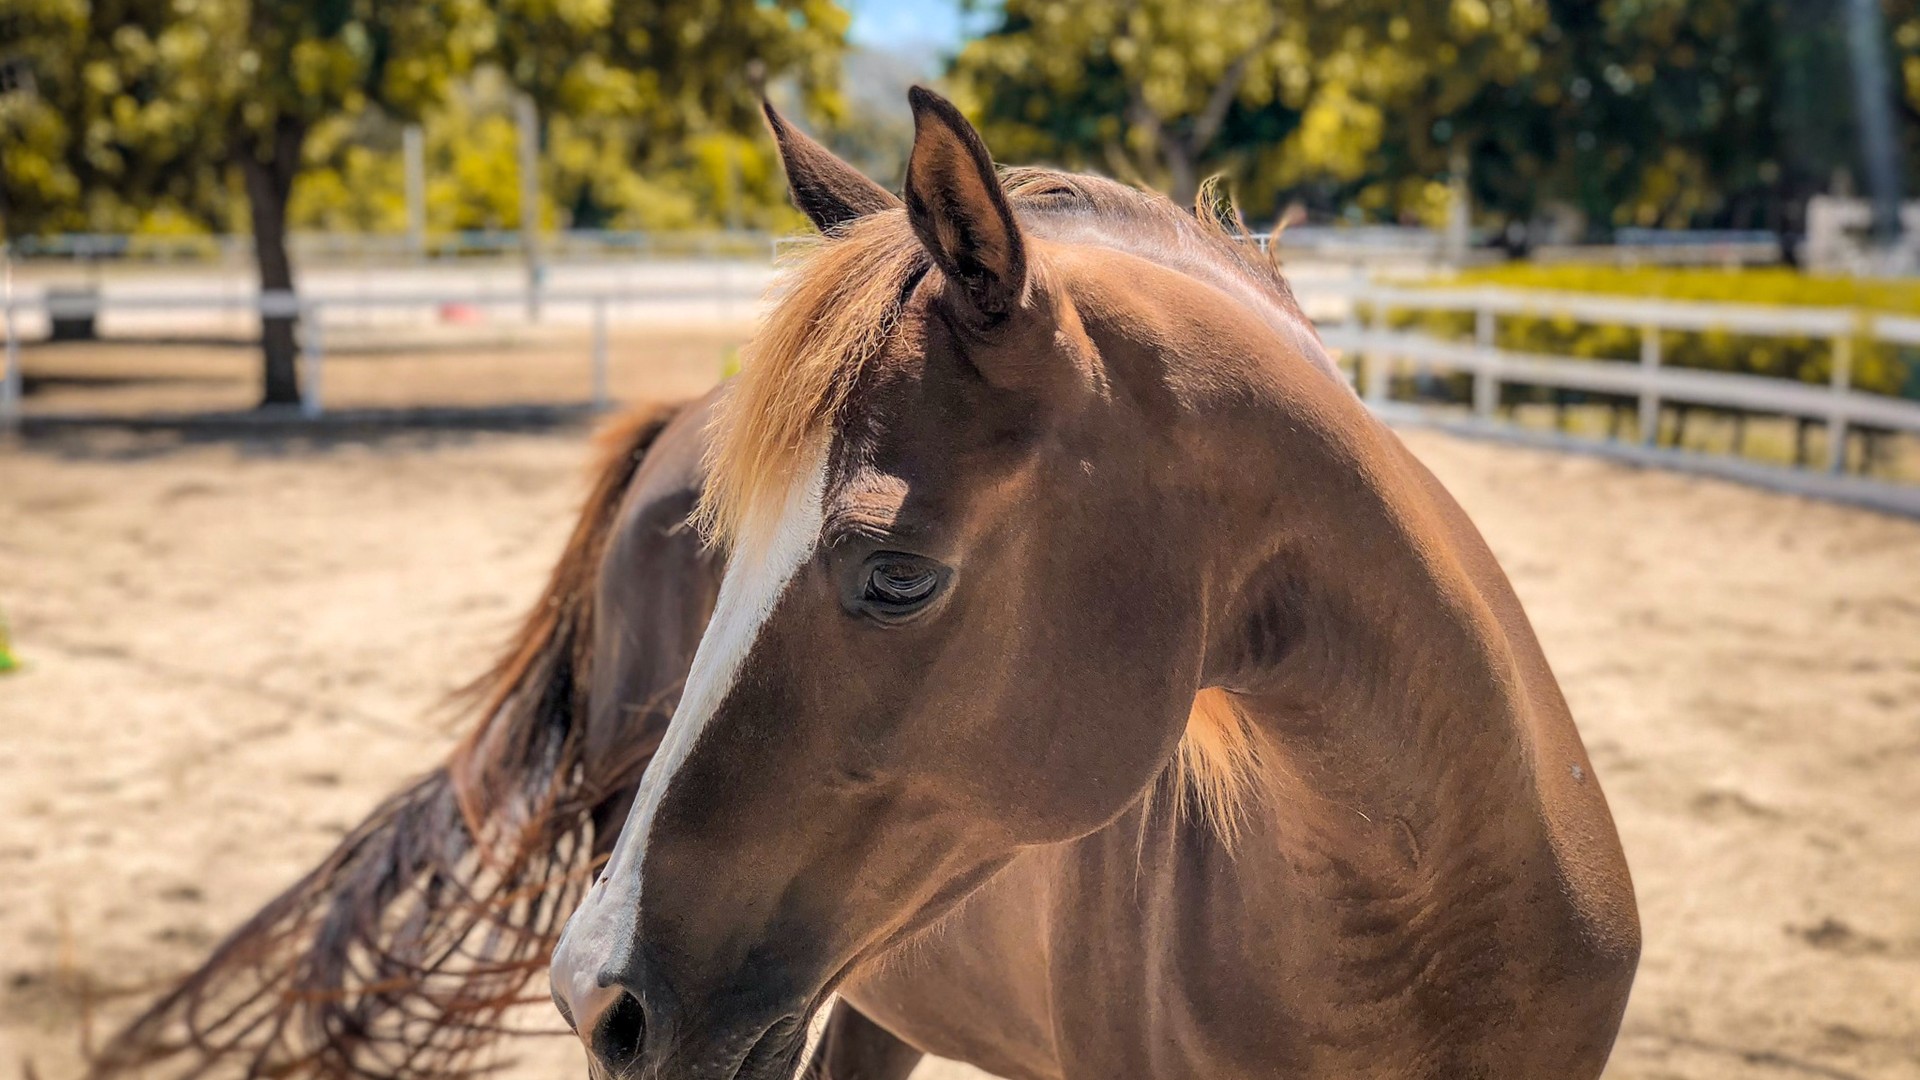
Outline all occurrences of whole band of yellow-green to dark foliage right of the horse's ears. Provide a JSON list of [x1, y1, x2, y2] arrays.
[[954, 0, 1920, 236]]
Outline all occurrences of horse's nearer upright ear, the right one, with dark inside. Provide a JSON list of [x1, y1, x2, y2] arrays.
[[906, 86, 1027, 319]]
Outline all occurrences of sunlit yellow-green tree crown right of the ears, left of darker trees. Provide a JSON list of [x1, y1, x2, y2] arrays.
[[954, 0, 1540, 202]]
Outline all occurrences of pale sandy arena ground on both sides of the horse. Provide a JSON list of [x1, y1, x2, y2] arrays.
[[0, 332, 1920, 1080]]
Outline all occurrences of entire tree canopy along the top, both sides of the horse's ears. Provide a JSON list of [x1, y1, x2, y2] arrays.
[[0, 0, 1920, 247]]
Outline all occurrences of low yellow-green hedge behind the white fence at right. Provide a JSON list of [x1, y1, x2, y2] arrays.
[[1388, 265, 1920, 398]]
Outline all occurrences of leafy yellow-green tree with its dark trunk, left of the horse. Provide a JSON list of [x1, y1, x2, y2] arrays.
[[0, 0, 847, 405]]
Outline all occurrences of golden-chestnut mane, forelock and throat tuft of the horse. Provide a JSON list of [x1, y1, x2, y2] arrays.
[[695, 178, 1274, 844]]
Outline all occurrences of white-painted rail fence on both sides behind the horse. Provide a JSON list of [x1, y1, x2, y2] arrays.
[[0, 275, 1920, 513]]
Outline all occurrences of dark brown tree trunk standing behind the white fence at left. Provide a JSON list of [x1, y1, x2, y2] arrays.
[[238, 117, 307, 407]]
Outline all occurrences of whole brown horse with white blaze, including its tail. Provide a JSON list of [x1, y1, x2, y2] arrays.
[[104, 90, 1640, 1080]]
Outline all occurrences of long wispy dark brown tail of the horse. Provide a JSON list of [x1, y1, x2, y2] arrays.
[[92, 409, 691, 1080]]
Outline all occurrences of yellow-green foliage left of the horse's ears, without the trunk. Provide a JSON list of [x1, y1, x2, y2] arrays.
[[0, 0, 847, 234]]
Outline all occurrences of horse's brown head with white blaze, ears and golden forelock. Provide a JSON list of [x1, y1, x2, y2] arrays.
[[551, 88, 1357, 1078]]
